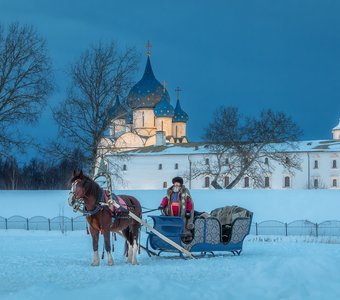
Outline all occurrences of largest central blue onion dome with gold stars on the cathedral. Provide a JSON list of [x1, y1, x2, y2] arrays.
[[127, 57, 170, 109]]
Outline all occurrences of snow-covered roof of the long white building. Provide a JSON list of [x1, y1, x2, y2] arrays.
[[107, 140, 340, 156]]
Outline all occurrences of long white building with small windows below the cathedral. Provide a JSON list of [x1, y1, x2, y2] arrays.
[[107, 140, 340, 189]]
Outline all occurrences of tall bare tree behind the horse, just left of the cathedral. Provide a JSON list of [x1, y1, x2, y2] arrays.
[[54, 42, 137, 175]]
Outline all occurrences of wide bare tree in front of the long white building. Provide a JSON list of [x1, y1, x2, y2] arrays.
[[192, 107, 301, 189]]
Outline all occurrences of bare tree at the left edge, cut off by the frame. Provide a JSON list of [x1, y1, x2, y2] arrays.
[[0, 23, 53, 155]]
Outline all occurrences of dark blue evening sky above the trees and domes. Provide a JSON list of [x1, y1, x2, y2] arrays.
[[0, 0, 340, 157]]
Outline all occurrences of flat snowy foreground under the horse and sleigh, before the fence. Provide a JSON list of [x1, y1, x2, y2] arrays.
[[0, 230, 340, 300]]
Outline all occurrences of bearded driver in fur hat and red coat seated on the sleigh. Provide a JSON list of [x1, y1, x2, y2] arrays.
[[159, 177, 194, 242]]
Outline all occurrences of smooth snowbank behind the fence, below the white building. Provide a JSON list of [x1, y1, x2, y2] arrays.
[[0, 189, 340, 223]]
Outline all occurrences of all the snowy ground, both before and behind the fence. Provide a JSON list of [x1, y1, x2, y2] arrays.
[[0, 190, 340, 300]]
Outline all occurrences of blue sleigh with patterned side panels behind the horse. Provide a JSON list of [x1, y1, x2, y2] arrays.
[[146, 207, 253, 256]]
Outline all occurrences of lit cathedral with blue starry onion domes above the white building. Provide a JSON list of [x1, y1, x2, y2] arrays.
[[102, 51, 188, 151]]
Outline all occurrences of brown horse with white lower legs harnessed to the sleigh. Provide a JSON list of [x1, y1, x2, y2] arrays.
[[70, 171, 142, 266]]
